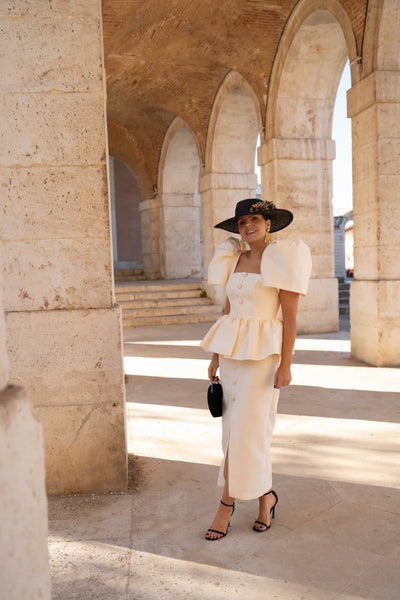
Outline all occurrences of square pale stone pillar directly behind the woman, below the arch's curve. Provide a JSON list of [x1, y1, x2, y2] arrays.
[[258, 138, 339, 333]]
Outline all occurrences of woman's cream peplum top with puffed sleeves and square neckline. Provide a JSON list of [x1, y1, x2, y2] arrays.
[[200, 238, 311, 360]]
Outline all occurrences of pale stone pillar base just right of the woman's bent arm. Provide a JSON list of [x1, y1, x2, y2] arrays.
[[297, 277, 339, 334]]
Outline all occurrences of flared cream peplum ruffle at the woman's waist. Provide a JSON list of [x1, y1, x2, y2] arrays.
[[200, 314, 282, 360]]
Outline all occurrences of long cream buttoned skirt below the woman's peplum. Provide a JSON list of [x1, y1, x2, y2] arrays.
[[218, 354, 280, 500]]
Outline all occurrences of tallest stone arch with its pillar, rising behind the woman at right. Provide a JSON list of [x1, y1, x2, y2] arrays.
[[259, 0, 359, 332]]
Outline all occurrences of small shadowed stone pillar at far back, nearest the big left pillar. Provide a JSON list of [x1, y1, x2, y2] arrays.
[[139, 198, 160, 279]]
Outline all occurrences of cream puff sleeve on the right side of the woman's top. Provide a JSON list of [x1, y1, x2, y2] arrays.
[[261, 239, 312, 296]]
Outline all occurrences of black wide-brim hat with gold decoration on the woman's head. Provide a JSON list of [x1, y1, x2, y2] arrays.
[[214, 198, 293, 233]]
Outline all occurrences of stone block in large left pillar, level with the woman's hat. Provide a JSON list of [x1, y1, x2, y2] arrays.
[[0, 165, 109, 240]]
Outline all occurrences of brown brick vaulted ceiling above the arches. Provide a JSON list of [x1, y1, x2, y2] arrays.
[[103, 0, 366, 188]]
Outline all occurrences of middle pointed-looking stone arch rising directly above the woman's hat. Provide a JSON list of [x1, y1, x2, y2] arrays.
[[201, 71, 262, 288]]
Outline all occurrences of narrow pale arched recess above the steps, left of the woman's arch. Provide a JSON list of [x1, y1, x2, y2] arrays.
[[158, 117, 202, 279]]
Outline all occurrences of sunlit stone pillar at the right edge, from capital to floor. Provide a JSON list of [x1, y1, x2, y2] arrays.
[[348, 71, 400, 366]]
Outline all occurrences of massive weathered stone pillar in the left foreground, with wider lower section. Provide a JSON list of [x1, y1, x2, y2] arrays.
[[0, 0, 127, 493]]
